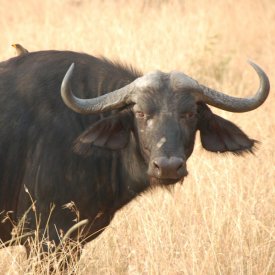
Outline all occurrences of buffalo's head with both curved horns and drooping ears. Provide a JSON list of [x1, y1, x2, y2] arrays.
[[61, 62, 269, 185]]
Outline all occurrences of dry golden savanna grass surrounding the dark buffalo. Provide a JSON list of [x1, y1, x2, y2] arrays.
[[0, 0, 275, 274]]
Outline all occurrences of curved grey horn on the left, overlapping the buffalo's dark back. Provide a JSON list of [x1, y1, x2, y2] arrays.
[[61, 63, 135, 114]]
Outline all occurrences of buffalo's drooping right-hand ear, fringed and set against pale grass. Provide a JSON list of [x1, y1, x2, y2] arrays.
[[198, 103, 257, 154]]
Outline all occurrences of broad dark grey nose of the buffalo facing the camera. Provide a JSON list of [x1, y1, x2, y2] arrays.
[[153, 157, 187, 179]]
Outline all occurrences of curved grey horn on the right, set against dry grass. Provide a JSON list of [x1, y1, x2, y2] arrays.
[[195, 61, 270, 113]]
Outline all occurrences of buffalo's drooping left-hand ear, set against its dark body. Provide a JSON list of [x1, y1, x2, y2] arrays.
[[73, 111, 132, 156]]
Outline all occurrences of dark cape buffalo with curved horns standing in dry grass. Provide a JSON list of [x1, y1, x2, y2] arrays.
[[0, 51, 269, 250]]
